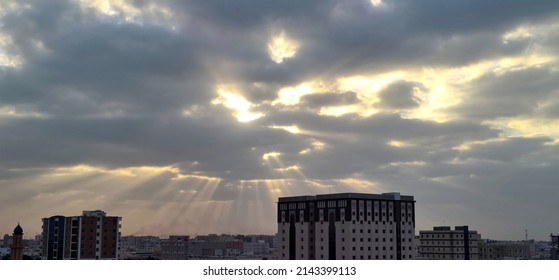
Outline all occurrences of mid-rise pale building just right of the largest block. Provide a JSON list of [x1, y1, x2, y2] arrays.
[[419, 226, 481, 260]]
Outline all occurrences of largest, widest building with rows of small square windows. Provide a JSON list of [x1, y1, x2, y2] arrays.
[[277, 193, 415, 260]]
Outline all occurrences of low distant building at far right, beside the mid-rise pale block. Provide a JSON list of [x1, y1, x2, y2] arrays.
[[479, 240, 536, 260]]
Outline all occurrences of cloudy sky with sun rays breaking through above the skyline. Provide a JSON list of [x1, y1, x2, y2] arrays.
[[0, 0, 559, 240]]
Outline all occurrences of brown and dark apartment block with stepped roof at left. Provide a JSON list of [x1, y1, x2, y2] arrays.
[[42, 210, 122, 260]]
